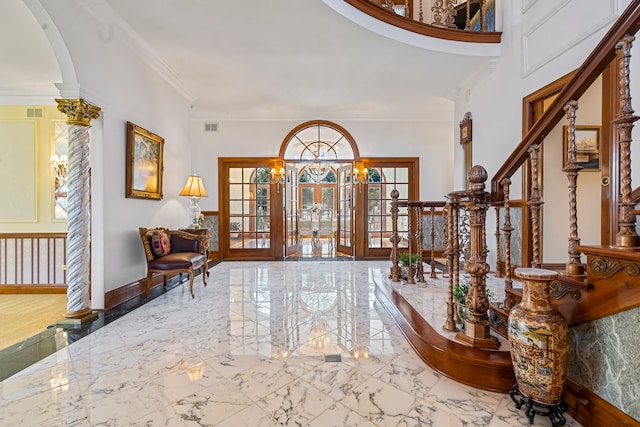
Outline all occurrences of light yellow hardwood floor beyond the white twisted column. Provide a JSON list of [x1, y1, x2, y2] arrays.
[[0, 294, 67, 349]]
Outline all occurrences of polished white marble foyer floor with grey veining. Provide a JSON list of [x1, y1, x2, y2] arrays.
[[0, 261, 579, 427]]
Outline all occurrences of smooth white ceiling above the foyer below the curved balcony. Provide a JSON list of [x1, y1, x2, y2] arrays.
[[0, 0, 498, 120]]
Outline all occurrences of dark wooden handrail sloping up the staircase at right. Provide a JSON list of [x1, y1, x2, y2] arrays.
[[491, 0, 640, 202]]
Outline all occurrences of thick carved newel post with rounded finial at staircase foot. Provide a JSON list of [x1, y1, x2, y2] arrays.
[[456, 165, 500, 349]]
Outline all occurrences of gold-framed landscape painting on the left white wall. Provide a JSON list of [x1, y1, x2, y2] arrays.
[[125, 122, 164, 200]]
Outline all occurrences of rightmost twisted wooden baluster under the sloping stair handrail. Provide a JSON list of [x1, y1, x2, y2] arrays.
[[613, 35, 640, 247]]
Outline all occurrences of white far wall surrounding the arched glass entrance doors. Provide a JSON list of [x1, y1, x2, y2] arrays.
[[190, 116, 454, 210]]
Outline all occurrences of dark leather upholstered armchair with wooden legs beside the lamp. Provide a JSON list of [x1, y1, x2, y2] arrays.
[[140, 227, 210, 298]]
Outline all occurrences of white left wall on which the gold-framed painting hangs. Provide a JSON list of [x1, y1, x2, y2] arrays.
[[37, 1, 191, 308]]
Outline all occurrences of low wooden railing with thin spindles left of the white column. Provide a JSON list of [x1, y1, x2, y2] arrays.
[[0, 233, 67, 292]]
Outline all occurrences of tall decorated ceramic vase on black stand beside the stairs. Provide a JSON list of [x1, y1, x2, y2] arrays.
[[507, 268, 569, 407]]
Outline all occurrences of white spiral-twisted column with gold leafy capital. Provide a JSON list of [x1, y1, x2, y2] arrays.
[[56, 99, 100, 320]]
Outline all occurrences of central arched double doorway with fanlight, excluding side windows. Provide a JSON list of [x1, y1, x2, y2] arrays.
[[280, 120, 360, 258]]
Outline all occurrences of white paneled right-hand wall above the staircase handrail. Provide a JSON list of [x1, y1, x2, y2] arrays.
[[454, 0, 629, 266]]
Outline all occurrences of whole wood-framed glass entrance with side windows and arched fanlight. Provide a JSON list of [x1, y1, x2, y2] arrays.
[[218, 120, 419, 259]]
